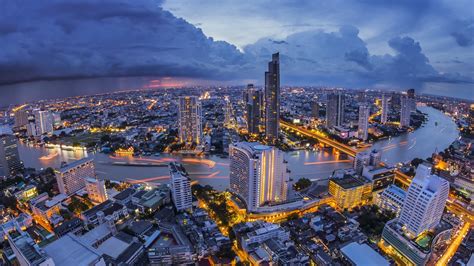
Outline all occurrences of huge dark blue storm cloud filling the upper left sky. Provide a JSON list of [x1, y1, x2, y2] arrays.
[[0, 0, 252, 83]]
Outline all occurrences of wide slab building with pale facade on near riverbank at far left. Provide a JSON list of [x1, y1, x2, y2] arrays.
[[55, 158, 96, 196]]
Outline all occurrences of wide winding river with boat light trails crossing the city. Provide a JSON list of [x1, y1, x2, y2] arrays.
[[19, 107, 458, 190]]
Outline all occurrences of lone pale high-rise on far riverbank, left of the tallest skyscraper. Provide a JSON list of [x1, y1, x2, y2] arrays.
[[178, 96, 202, 145]]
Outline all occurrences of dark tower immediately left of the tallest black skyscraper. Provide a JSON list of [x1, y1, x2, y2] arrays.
[[244, 84, 263, 134]]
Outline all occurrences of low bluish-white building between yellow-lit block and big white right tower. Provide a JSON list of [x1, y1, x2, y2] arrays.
[[375, 185, 406, 216]]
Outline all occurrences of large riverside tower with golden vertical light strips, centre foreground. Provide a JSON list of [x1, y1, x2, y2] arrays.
[[229, 142, 289, 211]]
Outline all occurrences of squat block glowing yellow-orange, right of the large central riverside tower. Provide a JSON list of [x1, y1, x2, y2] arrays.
[[329, 174, 372, 210]]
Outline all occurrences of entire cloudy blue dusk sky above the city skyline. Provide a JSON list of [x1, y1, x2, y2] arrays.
[[0, 0, 474, 105]]
